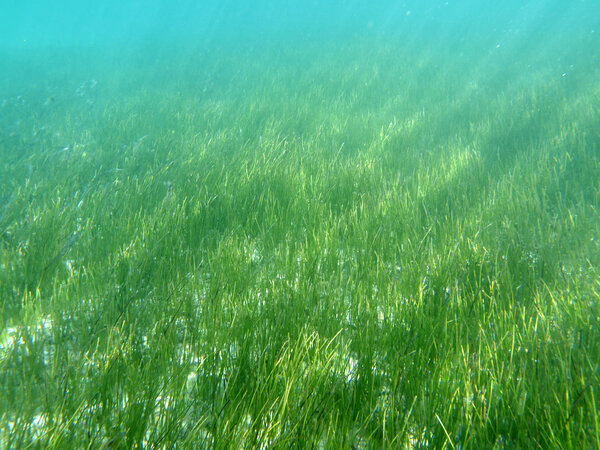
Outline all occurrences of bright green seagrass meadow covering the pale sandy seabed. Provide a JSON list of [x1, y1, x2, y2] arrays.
[[0, 37, 600, 448]]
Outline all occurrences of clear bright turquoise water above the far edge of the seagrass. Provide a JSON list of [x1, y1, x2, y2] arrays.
[[0, 0, 598, 59]]
